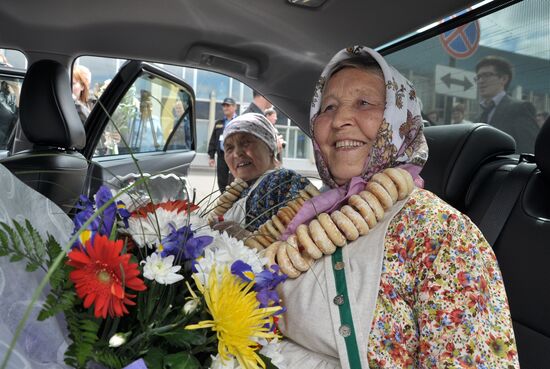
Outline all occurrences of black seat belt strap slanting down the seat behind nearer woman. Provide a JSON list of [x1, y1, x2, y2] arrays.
[[479, 154, 537, 246]]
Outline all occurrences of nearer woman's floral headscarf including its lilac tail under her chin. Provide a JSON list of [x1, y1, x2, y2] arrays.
[[282, 46, 428, 239]]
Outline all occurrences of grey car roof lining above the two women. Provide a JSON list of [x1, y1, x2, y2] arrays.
[[0, 0, 508, 130]]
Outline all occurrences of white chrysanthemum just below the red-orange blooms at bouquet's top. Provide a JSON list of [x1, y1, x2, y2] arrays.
[[127, 208, 187, 248]]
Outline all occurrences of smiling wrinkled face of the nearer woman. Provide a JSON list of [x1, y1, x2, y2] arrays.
[[313, 67, 386, 185]]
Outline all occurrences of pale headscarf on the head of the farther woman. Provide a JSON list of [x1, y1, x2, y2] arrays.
[[223, 113, 277, 155]]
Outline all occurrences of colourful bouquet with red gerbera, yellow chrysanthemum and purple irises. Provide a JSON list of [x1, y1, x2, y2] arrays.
[[0, 174, 292, 369]]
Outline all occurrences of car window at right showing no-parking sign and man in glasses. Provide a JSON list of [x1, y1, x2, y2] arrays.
[[387, 0, 550, 153]]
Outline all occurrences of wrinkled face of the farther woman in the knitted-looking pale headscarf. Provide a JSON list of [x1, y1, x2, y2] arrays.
[[223, 133, 275, 181]]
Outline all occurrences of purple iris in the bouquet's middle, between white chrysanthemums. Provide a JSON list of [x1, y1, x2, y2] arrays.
[[161, 225, 214, 261]]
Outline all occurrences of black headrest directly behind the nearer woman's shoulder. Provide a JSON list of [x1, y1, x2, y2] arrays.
[[420, 123, 516, 210]]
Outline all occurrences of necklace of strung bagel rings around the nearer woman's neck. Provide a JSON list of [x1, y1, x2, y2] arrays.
[[248, 168, 414, 278]]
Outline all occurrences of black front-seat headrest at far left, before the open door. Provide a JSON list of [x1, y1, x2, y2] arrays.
[[19, 60, 86, 149]]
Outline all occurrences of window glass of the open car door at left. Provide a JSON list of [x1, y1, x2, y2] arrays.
[[95, 72, 193, 156]]
